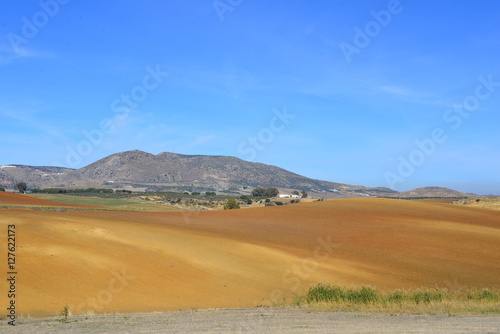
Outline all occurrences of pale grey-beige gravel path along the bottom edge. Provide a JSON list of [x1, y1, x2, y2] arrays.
[[0, 308, 500, 334]]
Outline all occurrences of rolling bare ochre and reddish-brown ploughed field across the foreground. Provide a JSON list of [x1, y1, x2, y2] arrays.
[[0, 192, 500, 316]]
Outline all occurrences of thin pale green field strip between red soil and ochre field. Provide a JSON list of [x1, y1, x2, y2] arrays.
[[28, 194, 183, 212]]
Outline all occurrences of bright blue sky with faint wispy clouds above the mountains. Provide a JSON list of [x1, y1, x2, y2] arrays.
[[0, 0, 500, 194]]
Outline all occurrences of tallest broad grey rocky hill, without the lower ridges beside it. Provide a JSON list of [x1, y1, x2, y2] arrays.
[[64, 150, 352, 191]]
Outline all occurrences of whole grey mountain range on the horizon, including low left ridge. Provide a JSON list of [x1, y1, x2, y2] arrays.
[[0, 150, 474, 197]]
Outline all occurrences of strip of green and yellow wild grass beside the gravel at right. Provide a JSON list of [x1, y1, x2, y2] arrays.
[[292, 284, 500, 314]]
